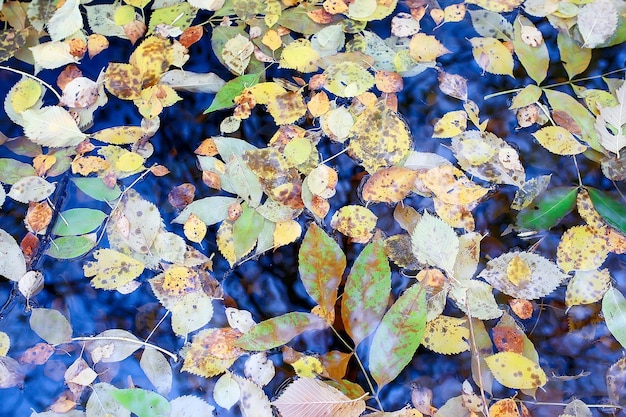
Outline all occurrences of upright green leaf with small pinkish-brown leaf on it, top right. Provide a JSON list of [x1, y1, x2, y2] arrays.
[[513, 16, 550, 84]]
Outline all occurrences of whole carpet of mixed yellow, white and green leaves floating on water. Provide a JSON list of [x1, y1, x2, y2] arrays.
[[0, 0, 626, 417]]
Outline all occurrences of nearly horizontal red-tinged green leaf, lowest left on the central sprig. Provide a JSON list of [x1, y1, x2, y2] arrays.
[[235, 312, 328, 351]]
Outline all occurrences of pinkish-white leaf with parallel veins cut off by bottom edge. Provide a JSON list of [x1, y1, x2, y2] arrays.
[[272, 378, 365, 417]]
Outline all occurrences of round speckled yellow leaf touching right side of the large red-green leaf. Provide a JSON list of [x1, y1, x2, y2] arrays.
[[422, 315, 470, 355]]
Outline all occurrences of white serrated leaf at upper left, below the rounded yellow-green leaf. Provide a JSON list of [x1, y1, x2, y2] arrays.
[[22, 106, 87, 148]]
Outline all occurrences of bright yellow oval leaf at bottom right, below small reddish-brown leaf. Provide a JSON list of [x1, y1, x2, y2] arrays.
[[485, 352, 547, 389]]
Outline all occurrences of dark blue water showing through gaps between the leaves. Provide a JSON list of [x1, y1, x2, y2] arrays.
[[0, 4, 626, 417]]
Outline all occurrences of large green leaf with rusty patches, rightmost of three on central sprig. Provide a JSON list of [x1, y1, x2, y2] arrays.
[[369, 285, 426, 390]]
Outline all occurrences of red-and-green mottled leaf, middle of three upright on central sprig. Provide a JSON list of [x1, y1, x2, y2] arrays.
[[341, 234, 391, 345]]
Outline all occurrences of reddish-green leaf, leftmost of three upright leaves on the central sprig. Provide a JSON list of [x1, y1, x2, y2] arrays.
[[298, 223, 346, 323]]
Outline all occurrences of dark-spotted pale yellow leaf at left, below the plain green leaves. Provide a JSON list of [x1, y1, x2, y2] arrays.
[[83, 249, 144, 290]]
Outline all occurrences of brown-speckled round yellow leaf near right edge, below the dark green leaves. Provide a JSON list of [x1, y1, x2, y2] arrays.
[[556, 225, 609, 272]]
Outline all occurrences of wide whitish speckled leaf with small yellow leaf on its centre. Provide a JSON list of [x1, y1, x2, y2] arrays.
[[478, 252, 567, 300]]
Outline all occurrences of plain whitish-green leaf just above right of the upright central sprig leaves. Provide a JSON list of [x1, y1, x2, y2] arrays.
[[411, 212, 459, 272]]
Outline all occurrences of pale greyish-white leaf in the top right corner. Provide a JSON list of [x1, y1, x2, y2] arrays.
[[577, 0, 618, 48]]
